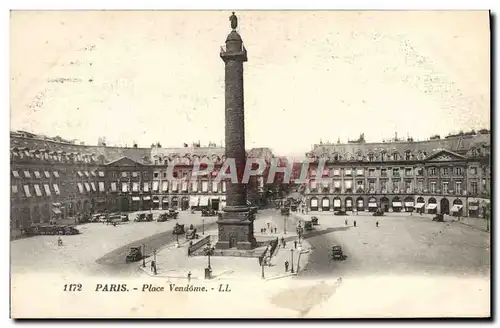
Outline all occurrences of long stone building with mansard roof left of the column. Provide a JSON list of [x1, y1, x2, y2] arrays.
[[10, 133, 273, 236]]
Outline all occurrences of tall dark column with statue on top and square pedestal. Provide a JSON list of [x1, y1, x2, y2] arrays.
[[216, 12, 256, 249]]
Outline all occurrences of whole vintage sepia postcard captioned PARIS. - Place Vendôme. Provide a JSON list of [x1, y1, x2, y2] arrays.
[[9, 11, 492, 319]]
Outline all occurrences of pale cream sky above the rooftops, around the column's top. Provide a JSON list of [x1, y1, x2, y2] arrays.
[[10, 11, 490, 155]]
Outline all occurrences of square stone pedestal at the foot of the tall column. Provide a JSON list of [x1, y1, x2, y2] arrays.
[[215, 212, 257, 250]]
